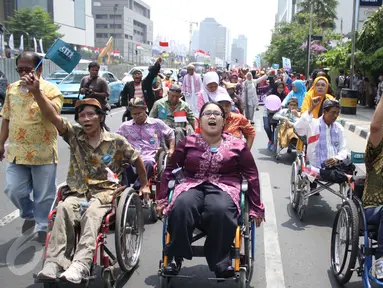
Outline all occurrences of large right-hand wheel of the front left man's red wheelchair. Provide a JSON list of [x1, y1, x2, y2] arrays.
[[115, 188, 144, 272]]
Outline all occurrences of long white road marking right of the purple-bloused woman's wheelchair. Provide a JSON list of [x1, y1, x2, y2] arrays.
[[260, 173, 286, 288]]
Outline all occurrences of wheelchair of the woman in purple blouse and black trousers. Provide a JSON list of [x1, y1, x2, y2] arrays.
[[158, 180, 255, 288]]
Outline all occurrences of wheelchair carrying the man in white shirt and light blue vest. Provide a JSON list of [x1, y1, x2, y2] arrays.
[[290, 148, 356, 221]]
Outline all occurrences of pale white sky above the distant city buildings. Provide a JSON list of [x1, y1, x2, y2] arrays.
[[143, 0, 278, 64]]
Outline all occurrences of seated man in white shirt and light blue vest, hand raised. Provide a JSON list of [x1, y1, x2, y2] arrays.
[[294, 97, 352, 183]]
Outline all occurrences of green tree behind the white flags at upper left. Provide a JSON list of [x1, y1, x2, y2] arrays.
[[6, 6, 63, 50]]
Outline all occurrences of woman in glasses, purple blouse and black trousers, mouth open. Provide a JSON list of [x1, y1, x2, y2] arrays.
[[157, 103, 264, 278]]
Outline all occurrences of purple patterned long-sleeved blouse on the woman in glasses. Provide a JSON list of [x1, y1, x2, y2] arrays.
[[157, 133, 264, 218]]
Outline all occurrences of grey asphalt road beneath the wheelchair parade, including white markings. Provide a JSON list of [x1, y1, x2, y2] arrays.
[[0, 108, 372, 288]]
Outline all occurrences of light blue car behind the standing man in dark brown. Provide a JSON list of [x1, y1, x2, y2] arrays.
[[58, 70, 124, 112]]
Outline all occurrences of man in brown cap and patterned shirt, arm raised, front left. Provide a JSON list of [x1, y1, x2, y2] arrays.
[[25, 96, 149, 283]]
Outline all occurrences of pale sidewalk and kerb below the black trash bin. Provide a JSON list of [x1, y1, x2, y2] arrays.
[[339, 105, 375, 139]]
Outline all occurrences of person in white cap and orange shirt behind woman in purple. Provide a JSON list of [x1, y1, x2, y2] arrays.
[[216, 93, 255, 149]]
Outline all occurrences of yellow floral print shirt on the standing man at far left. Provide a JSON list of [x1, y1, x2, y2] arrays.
[[1, 79, 64, 165]]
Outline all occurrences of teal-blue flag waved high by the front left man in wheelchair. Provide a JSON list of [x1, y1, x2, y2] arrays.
[[45, 39, 81, 73]]
